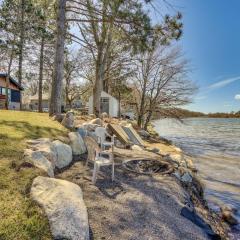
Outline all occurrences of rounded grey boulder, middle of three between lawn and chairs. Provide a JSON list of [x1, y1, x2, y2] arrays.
[[53, 140, 72, 169]]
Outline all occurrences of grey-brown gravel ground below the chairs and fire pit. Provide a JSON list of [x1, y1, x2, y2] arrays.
[[56, 157, 208, 240]]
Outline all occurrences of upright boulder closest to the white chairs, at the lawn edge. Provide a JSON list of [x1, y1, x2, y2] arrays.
[[68, 132, 87, 155]]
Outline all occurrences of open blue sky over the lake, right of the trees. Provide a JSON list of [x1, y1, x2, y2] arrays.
[[175, 0, 240, 112]]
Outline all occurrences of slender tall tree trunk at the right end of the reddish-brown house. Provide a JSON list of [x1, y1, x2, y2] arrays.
[[18, 0, 25, 110]]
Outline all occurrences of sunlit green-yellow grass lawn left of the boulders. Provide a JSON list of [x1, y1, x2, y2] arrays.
[[0, 110, 67, 240]]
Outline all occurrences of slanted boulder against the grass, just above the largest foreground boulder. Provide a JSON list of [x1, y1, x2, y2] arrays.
[[24, 149, 54, 177]]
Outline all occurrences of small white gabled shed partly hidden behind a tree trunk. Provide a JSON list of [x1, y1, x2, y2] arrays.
[[88, 91, 119, 117]]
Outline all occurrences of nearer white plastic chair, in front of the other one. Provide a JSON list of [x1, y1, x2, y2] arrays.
[[84, 137, 114, 184]]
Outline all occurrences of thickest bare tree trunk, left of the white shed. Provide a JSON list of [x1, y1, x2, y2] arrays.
[[49, 0, 66, 116]]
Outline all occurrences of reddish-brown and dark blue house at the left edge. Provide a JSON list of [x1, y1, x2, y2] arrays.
[[0, 73, 23, 110]]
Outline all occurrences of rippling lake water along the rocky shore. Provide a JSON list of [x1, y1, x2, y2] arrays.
[[153, 118, 240, 236]]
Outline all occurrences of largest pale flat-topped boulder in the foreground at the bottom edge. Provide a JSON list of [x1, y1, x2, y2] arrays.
[[31, 176, 89, 240]]
